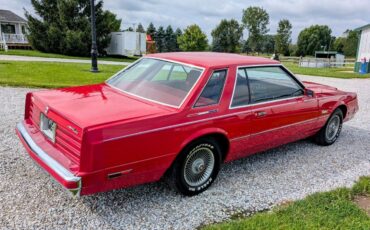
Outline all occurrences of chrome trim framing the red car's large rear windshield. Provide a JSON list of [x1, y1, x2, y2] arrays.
[[105, 57, 206, 109]]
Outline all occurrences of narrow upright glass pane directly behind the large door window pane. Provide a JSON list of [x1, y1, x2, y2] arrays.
[[231, 69, 250, 107]]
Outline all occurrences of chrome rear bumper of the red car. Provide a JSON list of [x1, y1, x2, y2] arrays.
[[17, 122, 82, 196]]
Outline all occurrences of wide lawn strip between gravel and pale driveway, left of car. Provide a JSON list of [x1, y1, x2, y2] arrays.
[[0, 61, 124, 88]]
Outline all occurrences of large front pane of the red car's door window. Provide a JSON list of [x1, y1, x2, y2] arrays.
[[245, 66, 303, 103]]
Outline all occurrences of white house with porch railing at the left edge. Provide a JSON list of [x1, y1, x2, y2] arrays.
[[0, 9, 28, 46]]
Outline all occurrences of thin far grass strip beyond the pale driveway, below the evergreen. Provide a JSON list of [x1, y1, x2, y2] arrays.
[[0, 50, 137, 62]]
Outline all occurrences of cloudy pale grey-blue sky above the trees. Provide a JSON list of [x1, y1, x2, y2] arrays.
[[0, 0, 370, 42]]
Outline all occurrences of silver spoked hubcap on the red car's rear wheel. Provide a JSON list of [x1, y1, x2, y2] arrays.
[[184, 147, 215, 187]]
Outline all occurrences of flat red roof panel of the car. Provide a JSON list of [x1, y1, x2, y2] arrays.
[[146, 52, 280, 68]]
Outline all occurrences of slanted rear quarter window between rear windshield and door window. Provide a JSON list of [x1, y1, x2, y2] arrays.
[[195, 70, 227, 107]]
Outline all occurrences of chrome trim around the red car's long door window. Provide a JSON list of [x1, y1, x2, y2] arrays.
[[229, 64, 305, 109]]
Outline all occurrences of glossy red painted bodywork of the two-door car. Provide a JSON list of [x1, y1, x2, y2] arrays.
[[16, 53, 358, 195]]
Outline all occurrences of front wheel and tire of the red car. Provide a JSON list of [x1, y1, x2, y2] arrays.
[[314, 109, 343, 146]]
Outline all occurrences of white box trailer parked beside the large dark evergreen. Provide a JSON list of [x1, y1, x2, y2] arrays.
[[107, 31, 146, 56]]
